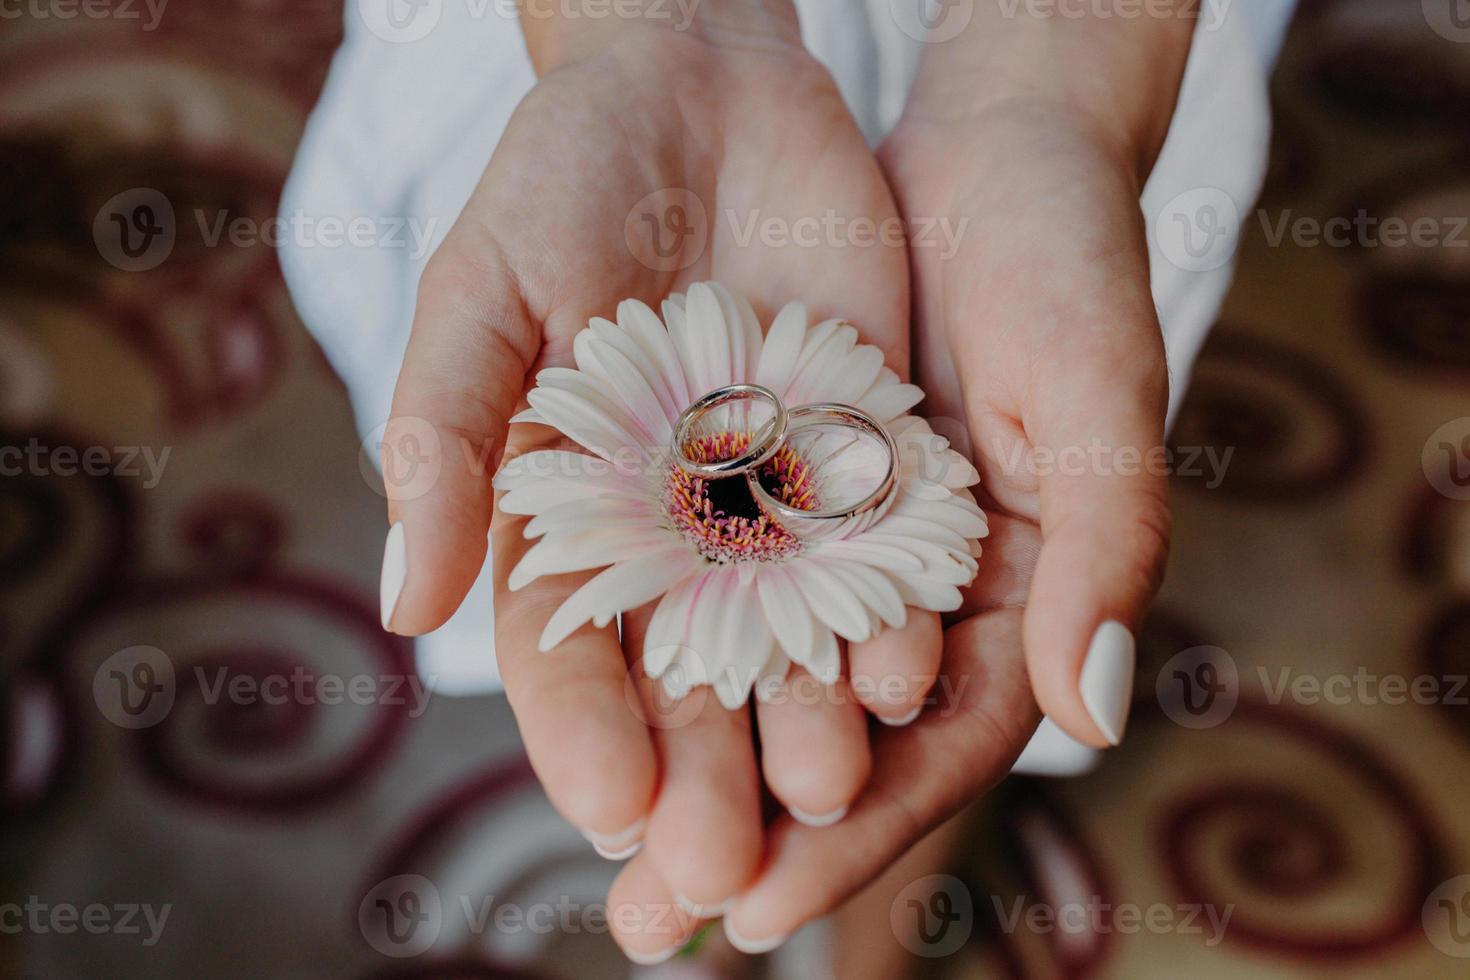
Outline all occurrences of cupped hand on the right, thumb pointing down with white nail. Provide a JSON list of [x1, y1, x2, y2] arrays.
[[705, 103, 1169, 945]]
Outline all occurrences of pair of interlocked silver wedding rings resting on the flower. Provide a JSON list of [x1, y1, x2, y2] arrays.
[[672, 383, 898, 533]]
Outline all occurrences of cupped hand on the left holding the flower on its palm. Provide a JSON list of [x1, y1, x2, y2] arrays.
[[373, 17, 939, 959]]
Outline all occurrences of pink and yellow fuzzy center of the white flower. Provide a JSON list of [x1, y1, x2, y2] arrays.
[[666, 432, 819, 564]]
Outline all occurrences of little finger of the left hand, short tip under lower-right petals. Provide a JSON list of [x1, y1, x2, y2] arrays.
[[848, 608, 944, 727]]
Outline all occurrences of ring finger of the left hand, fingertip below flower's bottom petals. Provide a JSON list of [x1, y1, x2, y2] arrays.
[[756, 667, 873, 827]]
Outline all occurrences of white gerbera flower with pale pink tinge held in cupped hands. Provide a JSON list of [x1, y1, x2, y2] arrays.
[[495, 282, 986, 708]]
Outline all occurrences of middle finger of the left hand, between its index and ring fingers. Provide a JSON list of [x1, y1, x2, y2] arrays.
[[623, 608, 763, 917]]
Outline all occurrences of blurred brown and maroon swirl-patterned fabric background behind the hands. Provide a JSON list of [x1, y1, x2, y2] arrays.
[[0, 0, 1470, 980]]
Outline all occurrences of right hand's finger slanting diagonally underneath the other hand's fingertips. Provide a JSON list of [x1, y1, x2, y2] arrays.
[[725, 610, 1038, 954]]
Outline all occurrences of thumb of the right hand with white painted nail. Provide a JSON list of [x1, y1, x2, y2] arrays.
[[1023, 318, 1169, 746]]
